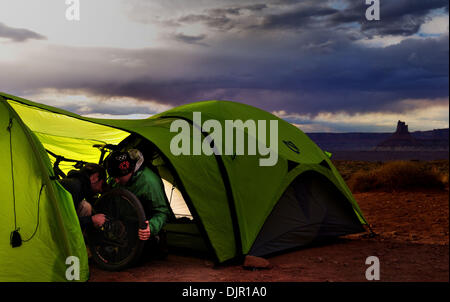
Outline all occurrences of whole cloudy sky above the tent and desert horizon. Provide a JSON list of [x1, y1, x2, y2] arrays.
[[0, 0, 449, 132]]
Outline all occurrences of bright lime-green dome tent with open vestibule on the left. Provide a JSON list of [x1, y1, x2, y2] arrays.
[[0, 93, 367, 281]]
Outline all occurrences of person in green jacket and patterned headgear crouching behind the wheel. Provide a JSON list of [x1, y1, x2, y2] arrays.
[[105, 149, 170, 258]]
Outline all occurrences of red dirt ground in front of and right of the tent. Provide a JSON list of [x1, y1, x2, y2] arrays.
[[90, 189, 449, 282]]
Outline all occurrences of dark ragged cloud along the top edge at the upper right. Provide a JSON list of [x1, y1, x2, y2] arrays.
[[176, 0, 449, 38]]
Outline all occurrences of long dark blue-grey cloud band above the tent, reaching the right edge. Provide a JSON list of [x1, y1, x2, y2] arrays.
[[115, 36, 448, 114]]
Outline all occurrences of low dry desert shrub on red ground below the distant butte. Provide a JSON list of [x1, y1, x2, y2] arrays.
[[348, 161, 448, 192]]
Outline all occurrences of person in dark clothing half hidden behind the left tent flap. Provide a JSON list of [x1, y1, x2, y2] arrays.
[[59, 163, 106, 230]]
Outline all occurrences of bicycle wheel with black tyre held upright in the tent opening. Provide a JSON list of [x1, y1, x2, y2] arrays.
[[88, 188, 146, 271]]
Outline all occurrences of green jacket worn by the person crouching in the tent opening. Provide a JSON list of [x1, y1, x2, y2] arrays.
[[113, 167, 170, 235]]
